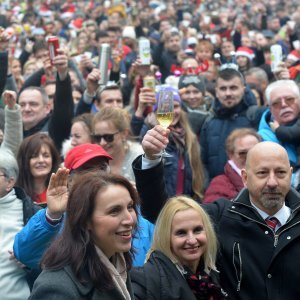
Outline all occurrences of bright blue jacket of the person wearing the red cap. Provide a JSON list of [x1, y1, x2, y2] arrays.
[[14, 209, 154, 269]]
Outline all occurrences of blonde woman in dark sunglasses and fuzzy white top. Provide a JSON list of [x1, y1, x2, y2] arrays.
[[92, 107, 143, 181]]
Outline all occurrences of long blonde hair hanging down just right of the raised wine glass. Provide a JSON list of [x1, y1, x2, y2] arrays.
[[179, 110, 205, 199]]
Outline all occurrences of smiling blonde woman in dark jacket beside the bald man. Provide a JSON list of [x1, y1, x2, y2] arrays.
[[131, 196, 226, 300]]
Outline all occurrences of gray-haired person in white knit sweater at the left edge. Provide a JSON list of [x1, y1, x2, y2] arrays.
[[0, 149, 38, 300]]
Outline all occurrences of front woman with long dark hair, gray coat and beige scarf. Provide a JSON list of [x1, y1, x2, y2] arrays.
[[29, 173, 138, 300]]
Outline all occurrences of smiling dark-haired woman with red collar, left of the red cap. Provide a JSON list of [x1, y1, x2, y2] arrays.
[[17, 133, 60, 204]]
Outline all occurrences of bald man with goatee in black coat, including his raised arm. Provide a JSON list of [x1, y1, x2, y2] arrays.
[[133, 126, 300, 300]]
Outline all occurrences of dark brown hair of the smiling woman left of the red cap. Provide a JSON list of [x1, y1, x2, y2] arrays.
[[17, 132, 60, 200]]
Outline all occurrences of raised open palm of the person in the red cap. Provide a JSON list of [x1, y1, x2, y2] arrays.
[[47, 168, 69, 219]]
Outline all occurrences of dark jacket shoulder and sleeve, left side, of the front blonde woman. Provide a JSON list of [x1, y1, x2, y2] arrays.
[[131, 251, 196, 300]]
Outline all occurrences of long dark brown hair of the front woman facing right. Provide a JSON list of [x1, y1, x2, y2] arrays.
[[42, 173, 139, 290]]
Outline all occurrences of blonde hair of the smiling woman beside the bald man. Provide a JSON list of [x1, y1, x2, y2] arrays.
[[146, 196, 217, 273]]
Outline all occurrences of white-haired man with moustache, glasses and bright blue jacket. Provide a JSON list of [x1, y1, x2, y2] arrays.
[[258, 80, 300, 185]]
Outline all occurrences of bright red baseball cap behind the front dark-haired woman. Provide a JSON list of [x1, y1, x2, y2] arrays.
[[64, 144, 112, 170]]
